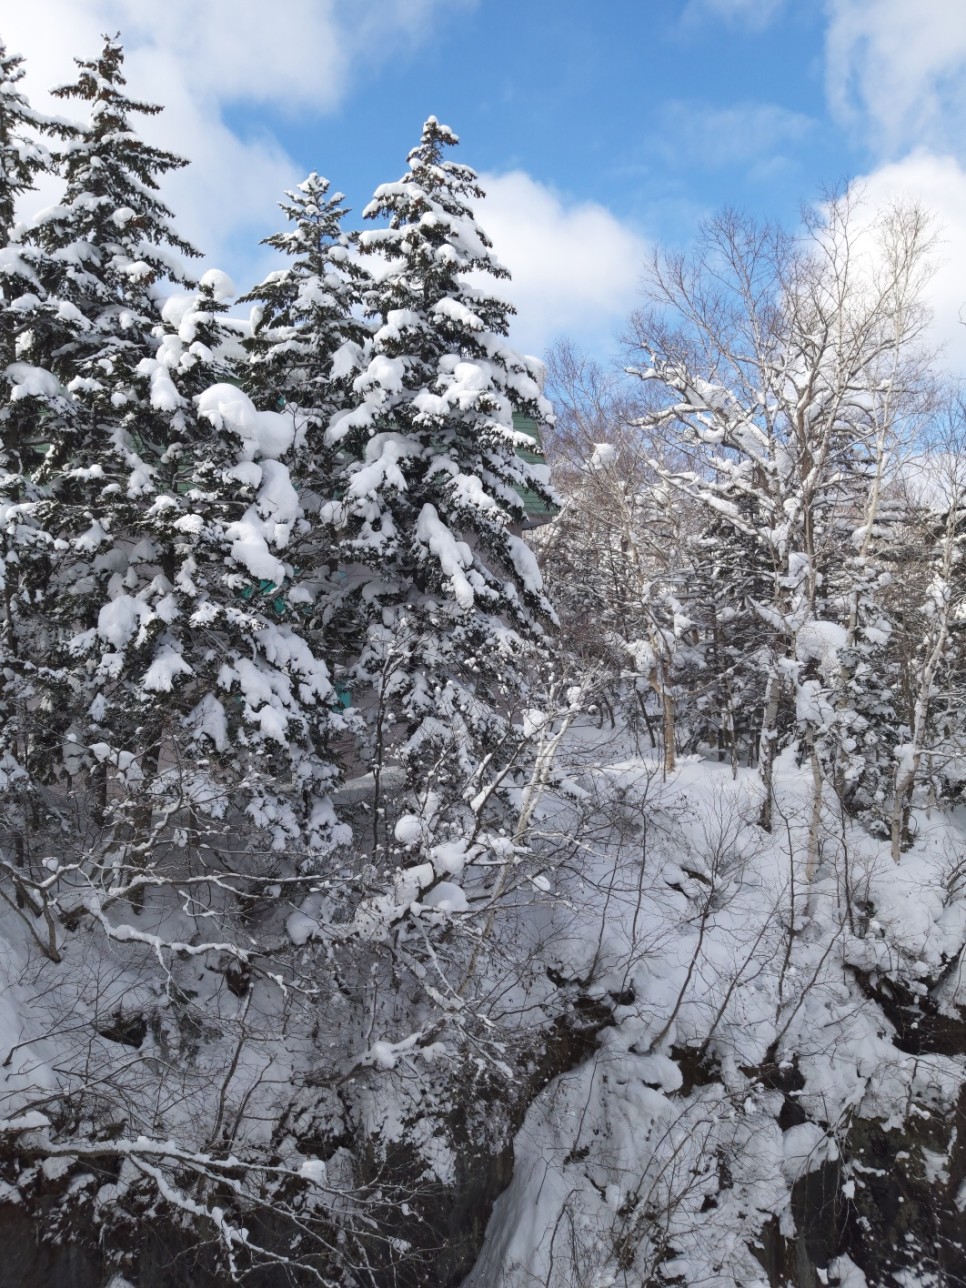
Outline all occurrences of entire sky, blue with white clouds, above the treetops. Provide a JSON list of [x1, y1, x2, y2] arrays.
[[9, 0, 966, 371]]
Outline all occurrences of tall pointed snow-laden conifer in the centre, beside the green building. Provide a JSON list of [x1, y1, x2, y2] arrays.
[[328, 117, 553, 777]]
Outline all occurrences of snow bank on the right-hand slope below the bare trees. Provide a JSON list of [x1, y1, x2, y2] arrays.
[[466, 729, 966, 1288]]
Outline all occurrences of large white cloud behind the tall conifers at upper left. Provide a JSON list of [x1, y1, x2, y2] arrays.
[[4, 0, 474, 281]]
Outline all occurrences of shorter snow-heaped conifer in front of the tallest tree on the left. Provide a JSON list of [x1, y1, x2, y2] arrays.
[[96, 273, 350, 863]]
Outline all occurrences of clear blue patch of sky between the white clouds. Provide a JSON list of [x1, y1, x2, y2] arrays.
[[227, 0, 834, 237]]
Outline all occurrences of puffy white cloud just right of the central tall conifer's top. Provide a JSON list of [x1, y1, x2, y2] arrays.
[[478, 170, 648, 354]]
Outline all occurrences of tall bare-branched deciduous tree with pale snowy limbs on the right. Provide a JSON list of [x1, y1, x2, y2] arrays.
[[635, 197, 930, 827]]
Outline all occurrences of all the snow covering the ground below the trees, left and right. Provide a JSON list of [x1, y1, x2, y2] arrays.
[[0, 720, 966, 1288]]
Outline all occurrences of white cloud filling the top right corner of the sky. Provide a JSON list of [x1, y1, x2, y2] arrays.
[[826, 0, 966, 156]]
